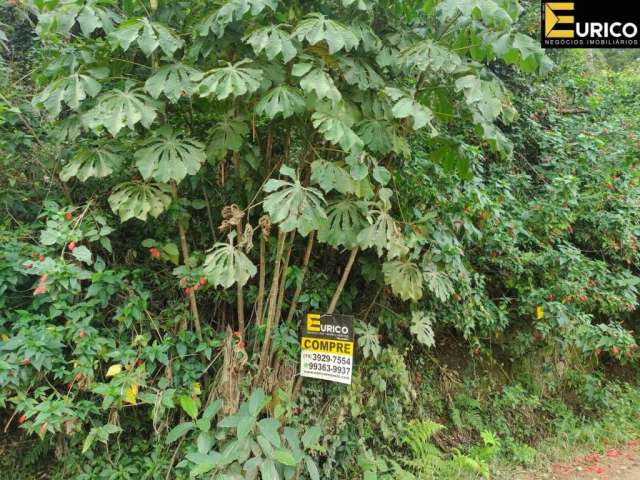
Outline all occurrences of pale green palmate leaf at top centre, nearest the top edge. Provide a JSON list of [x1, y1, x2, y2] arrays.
[[291, 13, 359, 55]]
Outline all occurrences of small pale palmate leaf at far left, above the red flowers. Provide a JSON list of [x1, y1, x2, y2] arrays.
[[60, 144, 122, 182]]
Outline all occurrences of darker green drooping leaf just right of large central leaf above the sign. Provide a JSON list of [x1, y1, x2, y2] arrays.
[[318, 199, 367, 248]]
